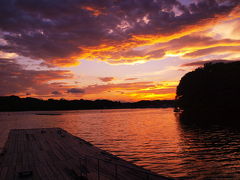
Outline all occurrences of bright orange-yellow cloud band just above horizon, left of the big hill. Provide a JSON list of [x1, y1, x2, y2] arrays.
[[48, 81, 177, 101]]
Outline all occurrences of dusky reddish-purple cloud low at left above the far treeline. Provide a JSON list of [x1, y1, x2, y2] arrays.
[[0, 59, 73, 96]]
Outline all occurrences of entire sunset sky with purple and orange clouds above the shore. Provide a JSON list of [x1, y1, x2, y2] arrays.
[[0, 0, 240, 102]]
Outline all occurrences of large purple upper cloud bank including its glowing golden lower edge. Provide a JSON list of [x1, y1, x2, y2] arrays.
[[0, 0, 240, 67]]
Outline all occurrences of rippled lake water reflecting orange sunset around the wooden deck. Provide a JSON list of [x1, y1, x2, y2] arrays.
[[0, 108, 240, 179]]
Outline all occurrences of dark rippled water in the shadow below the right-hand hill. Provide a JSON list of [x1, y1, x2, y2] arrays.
[[177, 112, 240, 179]]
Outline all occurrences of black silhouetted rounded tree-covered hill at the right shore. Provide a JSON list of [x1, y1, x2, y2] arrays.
[[176, 61, 240, 122]]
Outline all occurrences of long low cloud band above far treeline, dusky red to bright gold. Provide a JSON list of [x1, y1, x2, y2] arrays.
[[0, 59, 177, 101]]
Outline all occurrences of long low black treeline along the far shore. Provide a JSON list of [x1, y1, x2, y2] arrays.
[[0, 96, 174, 111]]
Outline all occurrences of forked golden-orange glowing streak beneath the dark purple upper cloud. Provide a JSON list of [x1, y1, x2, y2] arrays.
[[72, 10, 240, 64]]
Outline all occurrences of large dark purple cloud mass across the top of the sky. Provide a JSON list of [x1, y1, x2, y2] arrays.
[[0, 0, 239, 65]]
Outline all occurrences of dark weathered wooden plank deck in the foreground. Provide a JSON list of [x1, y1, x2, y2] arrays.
[[0, 128, 170, 180]]
